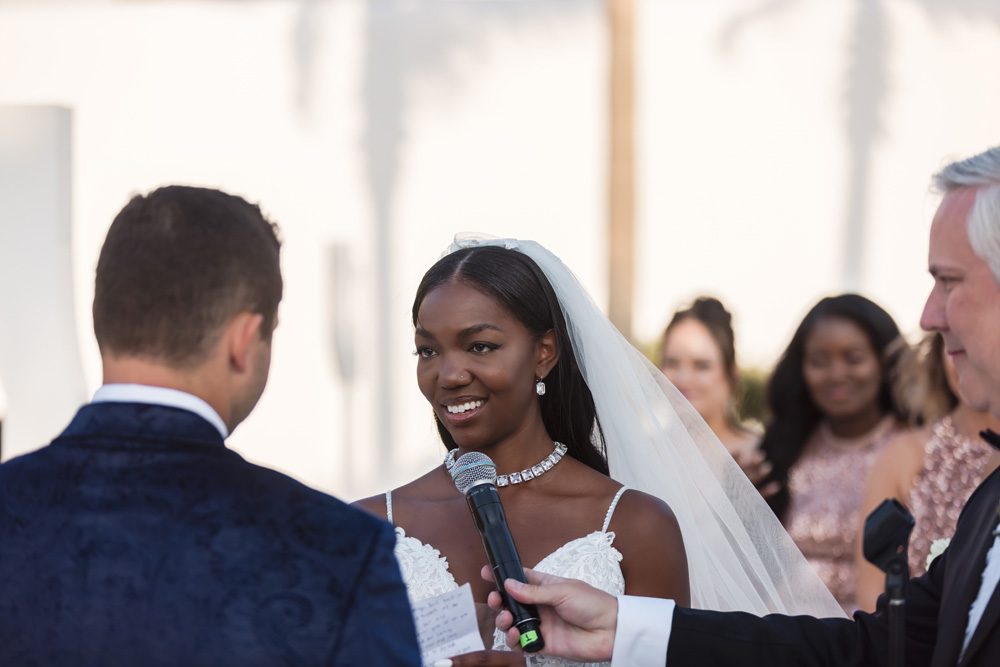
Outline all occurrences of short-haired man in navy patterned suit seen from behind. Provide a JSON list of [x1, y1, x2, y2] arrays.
[[0, 186, 420, 665]]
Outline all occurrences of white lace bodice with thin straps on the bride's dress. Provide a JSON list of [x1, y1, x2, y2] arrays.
[[386, 487, 627, 667]]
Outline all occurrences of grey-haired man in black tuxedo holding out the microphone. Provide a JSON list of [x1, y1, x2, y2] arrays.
[[478, 147, 1000, 667]]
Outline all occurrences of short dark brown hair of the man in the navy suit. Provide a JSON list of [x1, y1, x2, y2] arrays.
[[93, 185, 282, 367]]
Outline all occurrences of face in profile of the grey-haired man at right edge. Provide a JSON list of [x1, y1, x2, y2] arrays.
[[920, 188, 1000, 416]]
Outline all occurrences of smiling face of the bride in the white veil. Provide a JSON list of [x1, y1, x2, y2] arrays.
[[414, 282, 549, 449]]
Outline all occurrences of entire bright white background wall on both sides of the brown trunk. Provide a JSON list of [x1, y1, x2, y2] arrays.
[[0, 0, 1000, 498]]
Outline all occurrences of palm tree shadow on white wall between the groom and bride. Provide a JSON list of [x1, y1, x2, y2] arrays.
[[362, 0, 601, 470]]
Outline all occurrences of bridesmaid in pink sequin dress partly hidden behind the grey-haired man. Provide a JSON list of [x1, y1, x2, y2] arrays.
[[856, 333, 1000, 611]]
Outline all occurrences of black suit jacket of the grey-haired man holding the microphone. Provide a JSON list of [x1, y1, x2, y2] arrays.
[[667, 462, 1000, 667]]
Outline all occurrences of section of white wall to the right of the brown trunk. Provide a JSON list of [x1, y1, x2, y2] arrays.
[[635, 0, 1000, 368]]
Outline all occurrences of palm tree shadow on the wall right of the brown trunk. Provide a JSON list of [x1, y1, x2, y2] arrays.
[[719, 0, 1000, 291]]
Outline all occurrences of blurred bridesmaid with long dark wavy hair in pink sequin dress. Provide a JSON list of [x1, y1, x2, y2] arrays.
[[761, 294, 906, 613]]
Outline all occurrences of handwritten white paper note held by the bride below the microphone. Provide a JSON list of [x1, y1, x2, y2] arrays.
[[413, 584, 484, 667]]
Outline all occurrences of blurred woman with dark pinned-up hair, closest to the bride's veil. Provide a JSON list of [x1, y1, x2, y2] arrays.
[[659, 297, 760, 461]]
